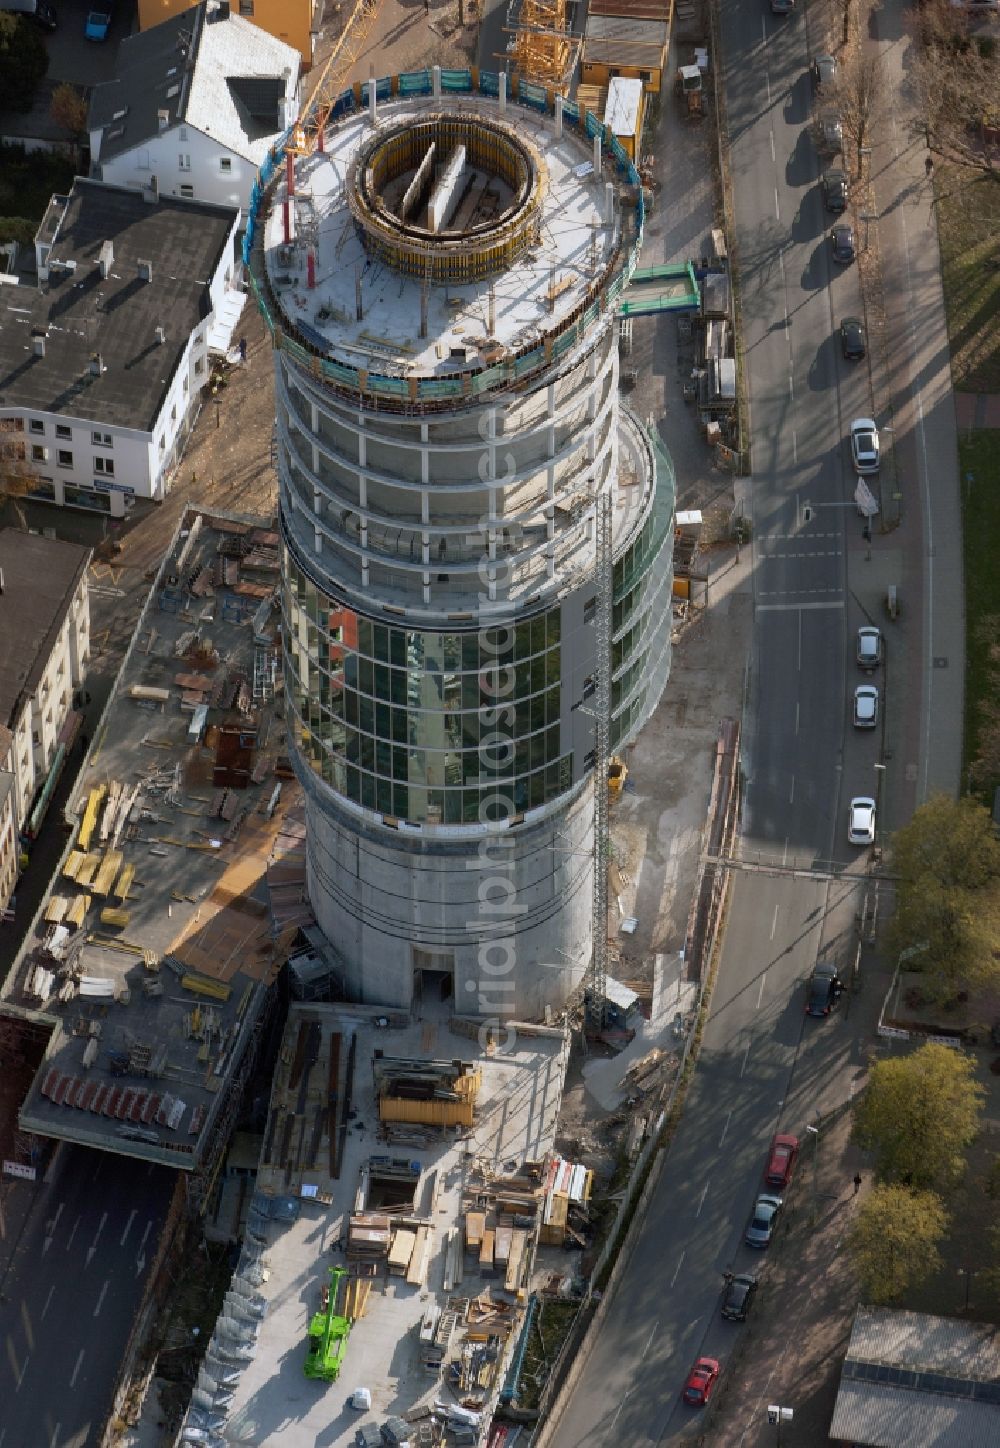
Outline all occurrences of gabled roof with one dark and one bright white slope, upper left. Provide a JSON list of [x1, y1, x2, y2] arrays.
[[88, 0, 301, 165]]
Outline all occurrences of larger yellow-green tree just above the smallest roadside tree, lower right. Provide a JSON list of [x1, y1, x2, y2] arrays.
[[854, 1043, 986, 1189]]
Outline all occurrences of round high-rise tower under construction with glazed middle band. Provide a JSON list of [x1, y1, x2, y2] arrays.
[[247, 74, 673, 1018]]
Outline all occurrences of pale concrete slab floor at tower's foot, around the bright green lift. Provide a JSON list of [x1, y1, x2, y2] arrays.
[[211, 1003, 569, 1448]]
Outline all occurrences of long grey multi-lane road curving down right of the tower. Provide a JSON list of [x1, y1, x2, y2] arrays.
[[551, 0, 880, 1448]]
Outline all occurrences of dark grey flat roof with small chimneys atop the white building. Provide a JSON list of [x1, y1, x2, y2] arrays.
[[0, 177, 240, 433]]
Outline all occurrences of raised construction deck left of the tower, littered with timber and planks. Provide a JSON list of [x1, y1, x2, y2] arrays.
[[3, 510, 301, 1193]]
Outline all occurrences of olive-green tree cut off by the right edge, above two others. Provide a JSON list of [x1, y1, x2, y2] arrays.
[[887, 795, 1000, 1002]]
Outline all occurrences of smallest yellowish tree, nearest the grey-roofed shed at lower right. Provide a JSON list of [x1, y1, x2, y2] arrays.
[[847, 1184, 948, 1306]]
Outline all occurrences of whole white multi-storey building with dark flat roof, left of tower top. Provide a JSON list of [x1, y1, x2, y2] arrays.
[[0, 177, 240, 517]]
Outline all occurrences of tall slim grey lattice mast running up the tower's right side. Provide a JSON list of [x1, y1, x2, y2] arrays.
[[590, 491, 614, 1027]]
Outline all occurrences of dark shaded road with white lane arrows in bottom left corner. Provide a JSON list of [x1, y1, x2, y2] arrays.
[[0, 1147, 174, 1448]]
